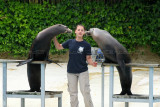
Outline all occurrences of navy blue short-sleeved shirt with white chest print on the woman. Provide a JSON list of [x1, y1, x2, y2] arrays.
[[62, 39, 91, 73]]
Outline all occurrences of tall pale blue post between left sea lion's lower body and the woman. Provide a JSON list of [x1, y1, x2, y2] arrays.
[[41, 63, 45, 107]]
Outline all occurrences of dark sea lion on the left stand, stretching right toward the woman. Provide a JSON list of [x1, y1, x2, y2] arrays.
[[17, 24, 72, 92]]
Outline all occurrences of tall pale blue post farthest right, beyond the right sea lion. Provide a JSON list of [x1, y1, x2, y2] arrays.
[[149, 67, 154, 107]]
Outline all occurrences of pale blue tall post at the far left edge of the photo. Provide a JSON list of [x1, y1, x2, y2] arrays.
[[3, 62, 7, 107]]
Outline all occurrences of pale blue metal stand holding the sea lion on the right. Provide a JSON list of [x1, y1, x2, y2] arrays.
[[101, 63, 160, 107]]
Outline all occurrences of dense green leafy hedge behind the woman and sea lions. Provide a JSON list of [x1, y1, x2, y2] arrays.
[[0, 0, 160, 56]]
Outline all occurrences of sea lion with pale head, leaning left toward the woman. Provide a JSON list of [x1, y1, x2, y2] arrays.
[[86, 28, 132, 95]]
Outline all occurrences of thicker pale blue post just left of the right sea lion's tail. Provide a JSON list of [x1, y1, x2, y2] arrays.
[[109, 65, 114, 107]]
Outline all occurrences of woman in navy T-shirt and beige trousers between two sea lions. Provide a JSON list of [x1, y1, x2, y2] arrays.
[[53, 25, 97, 107]]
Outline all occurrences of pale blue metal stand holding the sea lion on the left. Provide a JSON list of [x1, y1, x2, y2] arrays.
[[0, 59, 62, 107]]
